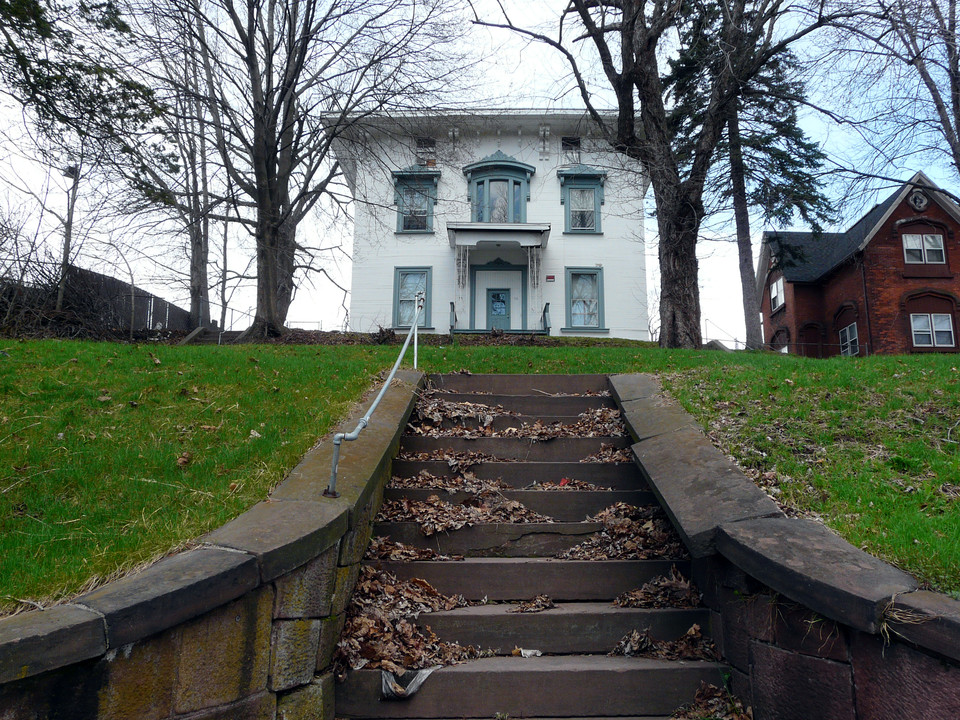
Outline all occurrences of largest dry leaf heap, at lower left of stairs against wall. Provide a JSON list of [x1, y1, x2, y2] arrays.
[[334, 566, 483, 680]]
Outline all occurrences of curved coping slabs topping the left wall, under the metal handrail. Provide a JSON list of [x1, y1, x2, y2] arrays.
[[0, 371, 423, 683]]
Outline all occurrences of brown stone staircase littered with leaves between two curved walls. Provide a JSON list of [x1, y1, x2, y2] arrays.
[[336, 375, 725, 718]]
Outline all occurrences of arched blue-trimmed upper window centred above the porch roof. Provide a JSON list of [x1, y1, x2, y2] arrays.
[[463, 150, 536, 223]]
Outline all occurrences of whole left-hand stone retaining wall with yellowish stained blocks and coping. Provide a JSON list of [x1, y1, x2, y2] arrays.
[[0, 372, 422, 720]]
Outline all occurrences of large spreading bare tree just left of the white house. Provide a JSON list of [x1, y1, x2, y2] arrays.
[[125, 0, 470, 338]]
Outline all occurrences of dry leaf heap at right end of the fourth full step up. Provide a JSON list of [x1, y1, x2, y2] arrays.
[[557, 502, 687, 560]]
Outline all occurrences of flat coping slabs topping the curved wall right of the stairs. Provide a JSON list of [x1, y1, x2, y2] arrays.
[[610, 375, 960, 662]]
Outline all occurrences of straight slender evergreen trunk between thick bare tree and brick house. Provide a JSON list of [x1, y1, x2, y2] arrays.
[[727, 109, 763, 350]]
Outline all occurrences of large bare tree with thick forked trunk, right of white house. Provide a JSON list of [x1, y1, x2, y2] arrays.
[[477, 0, 846, 347]]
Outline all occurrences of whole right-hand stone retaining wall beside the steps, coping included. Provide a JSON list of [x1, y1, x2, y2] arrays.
[[611, 375, 960, 720]]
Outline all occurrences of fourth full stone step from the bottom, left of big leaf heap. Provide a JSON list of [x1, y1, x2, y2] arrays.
[[373, 522, 603, 558]]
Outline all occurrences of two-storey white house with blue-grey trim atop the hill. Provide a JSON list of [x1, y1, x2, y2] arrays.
[[337, 110, 648, 339]]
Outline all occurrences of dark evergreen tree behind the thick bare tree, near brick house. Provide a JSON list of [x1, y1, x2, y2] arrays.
[[667, 10, 833, 349]]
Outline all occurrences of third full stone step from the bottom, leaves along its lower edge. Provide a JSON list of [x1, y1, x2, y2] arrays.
[[372, 558, 690, 602]]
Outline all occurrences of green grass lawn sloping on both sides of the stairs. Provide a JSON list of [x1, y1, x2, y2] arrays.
[[0, 341, 960, 612]]
